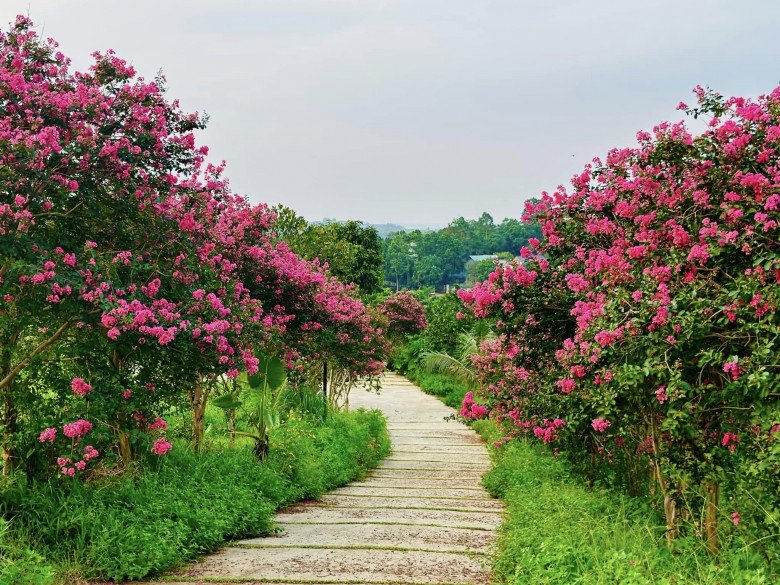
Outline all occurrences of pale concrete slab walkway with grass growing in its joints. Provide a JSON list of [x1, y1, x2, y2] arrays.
[[159, 374, 502, 585]]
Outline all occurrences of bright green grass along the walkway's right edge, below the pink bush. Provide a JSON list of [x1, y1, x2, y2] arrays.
[[474, 421, 778, 585]]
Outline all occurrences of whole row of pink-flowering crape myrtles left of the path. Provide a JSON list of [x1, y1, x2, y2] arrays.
[[0, 17, 383, 475]]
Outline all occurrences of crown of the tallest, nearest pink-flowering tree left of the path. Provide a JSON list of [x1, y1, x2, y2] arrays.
[[0, 17, 233, 472]]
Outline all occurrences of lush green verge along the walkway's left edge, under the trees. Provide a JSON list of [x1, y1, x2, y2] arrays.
[[0, 411, 390, 585]]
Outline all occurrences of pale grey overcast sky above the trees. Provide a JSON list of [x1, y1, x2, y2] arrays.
[[0, 0, 780, 224]]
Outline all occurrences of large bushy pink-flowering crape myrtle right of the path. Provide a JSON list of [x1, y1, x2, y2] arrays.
[[462, 88, 780, 555]]
